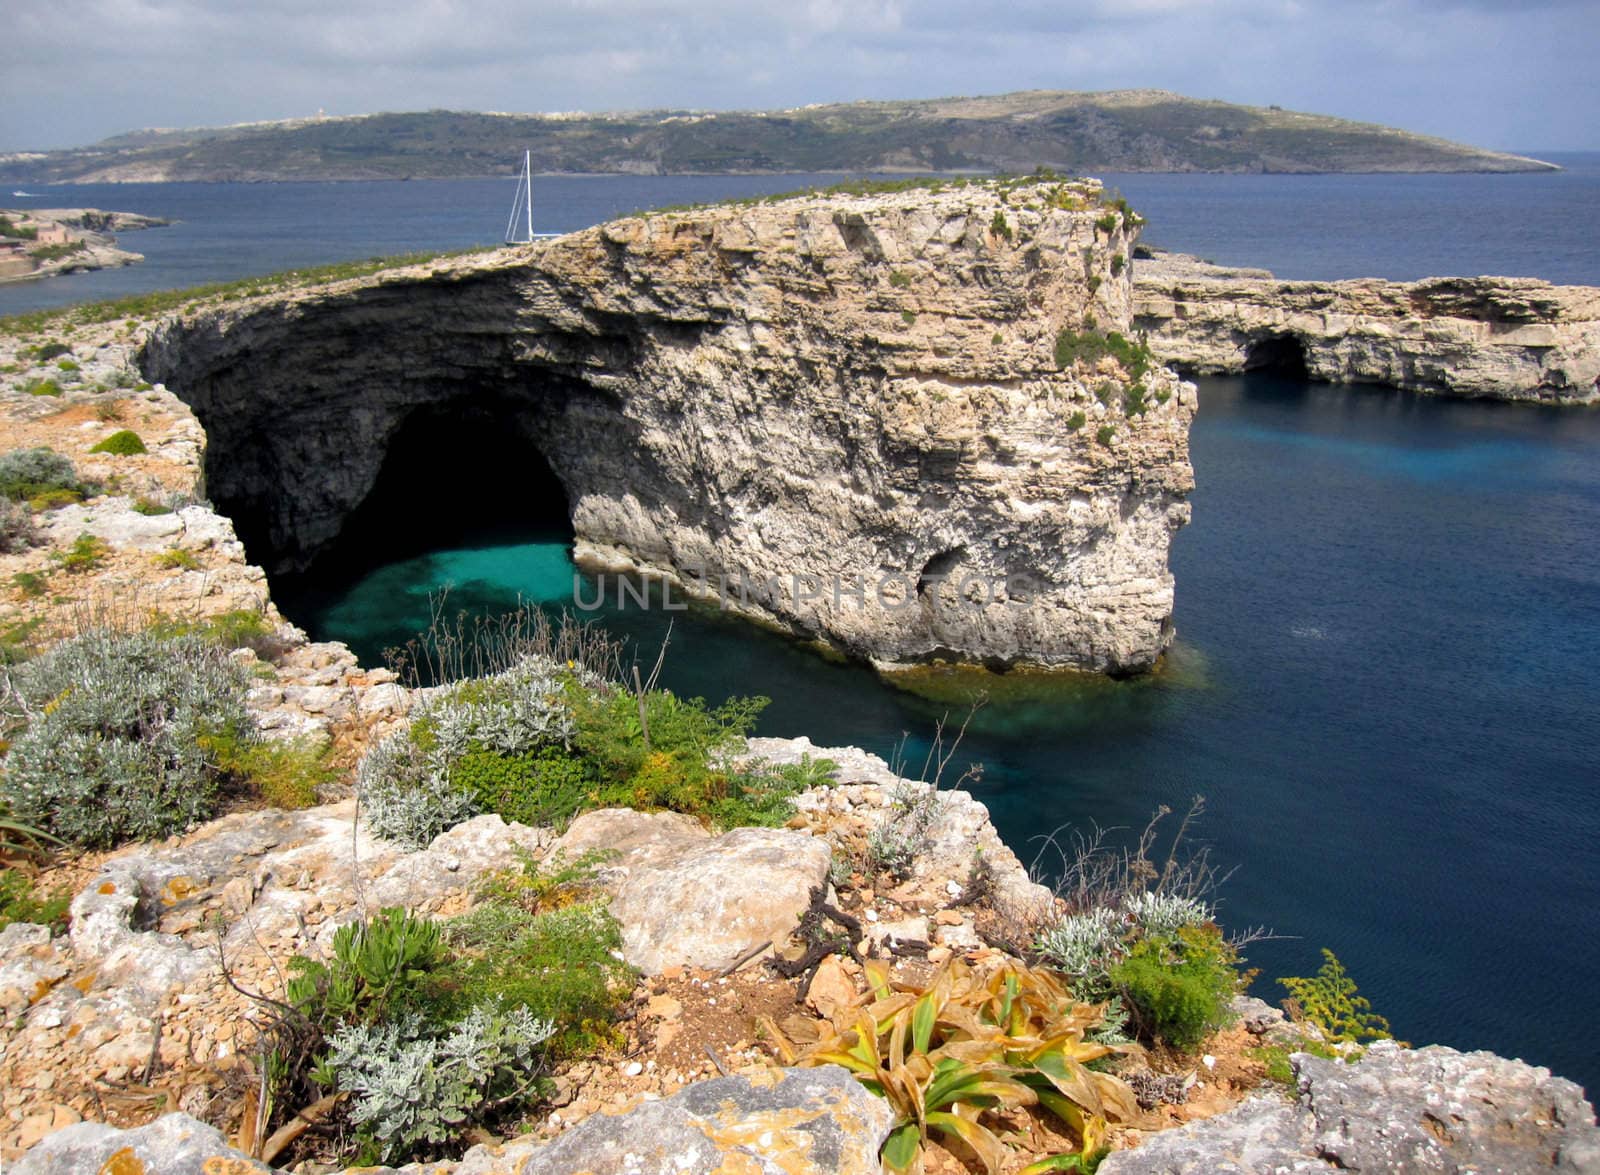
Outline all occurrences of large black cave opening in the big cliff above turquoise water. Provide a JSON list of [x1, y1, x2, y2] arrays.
[[296, 399, 573, 586]]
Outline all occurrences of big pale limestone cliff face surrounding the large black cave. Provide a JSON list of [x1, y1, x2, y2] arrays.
[[142, 181, 1195, 672]]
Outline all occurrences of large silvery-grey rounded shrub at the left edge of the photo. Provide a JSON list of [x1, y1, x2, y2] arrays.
[[0, 629, 250, 847]]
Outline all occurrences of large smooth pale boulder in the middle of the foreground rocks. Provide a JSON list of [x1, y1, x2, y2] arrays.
[[554, 808, 832, 975]]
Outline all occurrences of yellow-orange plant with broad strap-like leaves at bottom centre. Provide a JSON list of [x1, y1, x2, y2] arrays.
[[763, 959, 1138, 1173]]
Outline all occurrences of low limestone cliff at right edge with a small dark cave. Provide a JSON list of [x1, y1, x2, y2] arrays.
[[1134, 253, 1600, 403]]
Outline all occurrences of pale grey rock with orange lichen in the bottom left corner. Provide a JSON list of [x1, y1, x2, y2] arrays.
[[11, 1114, 272, 1175]]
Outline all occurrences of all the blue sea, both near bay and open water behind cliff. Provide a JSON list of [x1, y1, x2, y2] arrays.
[[0, 155, 1600, 1089]]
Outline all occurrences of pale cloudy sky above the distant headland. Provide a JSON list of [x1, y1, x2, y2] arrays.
[[0, 0, 1600, 152]]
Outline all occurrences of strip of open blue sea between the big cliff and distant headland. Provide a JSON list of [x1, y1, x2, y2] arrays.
[[0, 152, 1600, 314]]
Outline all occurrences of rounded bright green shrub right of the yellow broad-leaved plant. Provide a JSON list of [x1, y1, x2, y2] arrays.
[[1110, 927, 1238, 1052]]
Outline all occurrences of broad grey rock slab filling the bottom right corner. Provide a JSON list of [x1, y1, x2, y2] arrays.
[[1101, 1041, 1600, 1175]]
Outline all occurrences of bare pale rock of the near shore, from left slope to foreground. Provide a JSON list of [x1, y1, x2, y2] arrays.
[[0, 188, 1600, 1175]]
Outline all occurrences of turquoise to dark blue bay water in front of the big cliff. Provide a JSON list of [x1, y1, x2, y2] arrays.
[[288, 378, 1600, 1084]]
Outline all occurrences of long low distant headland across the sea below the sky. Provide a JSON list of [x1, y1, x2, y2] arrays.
[[0, 90, 1558, 184]]
